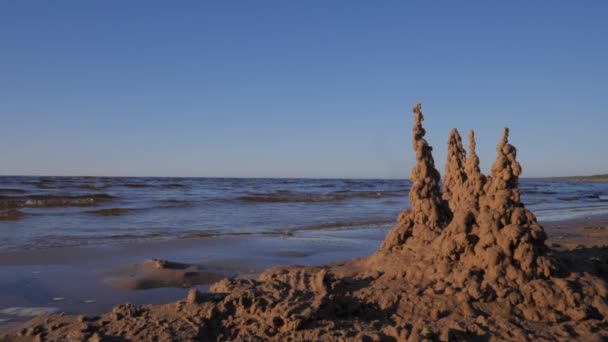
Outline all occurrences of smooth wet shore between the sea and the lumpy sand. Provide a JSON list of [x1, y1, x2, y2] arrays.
[[0, 215, 608, 335]]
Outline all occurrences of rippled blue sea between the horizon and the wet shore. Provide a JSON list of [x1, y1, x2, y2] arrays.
[[0, 176, 608, 249]]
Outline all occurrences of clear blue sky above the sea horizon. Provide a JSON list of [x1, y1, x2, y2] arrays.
[[0, 0, 608, 178]]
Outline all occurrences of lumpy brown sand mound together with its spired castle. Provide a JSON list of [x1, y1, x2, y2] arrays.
[[4, 105, 608, 341]]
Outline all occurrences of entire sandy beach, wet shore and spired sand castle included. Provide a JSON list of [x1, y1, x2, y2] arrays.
[[0, 105, 608, 341]]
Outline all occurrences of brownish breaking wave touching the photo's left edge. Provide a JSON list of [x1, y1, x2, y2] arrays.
[[0, 194, 116, 209]]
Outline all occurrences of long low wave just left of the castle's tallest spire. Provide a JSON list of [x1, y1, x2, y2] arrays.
[[237, 190, 405, 203]]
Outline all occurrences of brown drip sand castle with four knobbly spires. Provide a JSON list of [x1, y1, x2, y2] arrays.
[[381, 104, 556, 298]]
